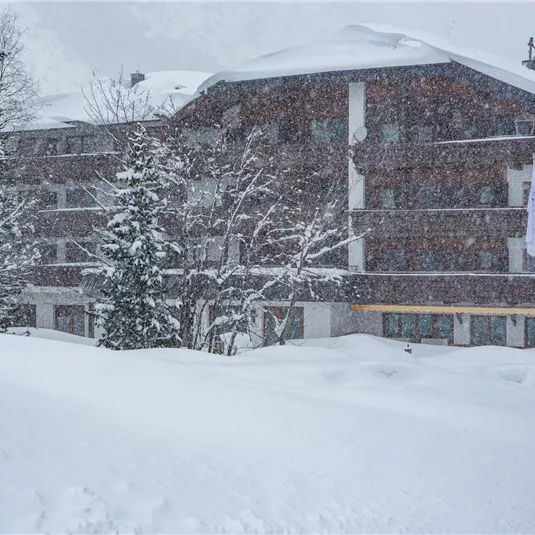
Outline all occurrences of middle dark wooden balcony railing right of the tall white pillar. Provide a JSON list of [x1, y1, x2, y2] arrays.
[[351, 207, 527, 238]]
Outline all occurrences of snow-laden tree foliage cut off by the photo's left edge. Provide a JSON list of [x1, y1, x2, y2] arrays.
[[0, 141, 39, 332]]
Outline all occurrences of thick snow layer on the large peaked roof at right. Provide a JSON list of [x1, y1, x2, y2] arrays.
[[199, 24, 535, 97]]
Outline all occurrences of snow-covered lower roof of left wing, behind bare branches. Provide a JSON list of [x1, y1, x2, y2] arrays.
[[29, 71, 214, 130]]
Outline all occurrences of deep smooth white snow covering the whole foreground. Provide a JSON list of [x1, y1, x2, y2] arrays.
[[0, 335, 535, 533]]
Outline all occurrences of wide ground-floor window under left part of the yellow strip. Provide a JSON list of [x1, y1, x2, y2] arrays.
[[383, 313, 453, 344]]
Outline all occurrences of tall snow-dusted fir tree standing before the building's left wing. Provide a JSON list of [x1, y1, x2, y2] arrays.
[[95, 125, 180, 349]]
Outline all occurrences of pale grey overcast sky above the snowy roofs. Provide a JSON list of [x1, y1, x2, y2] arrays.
[[7, 0, 535, 93]]
